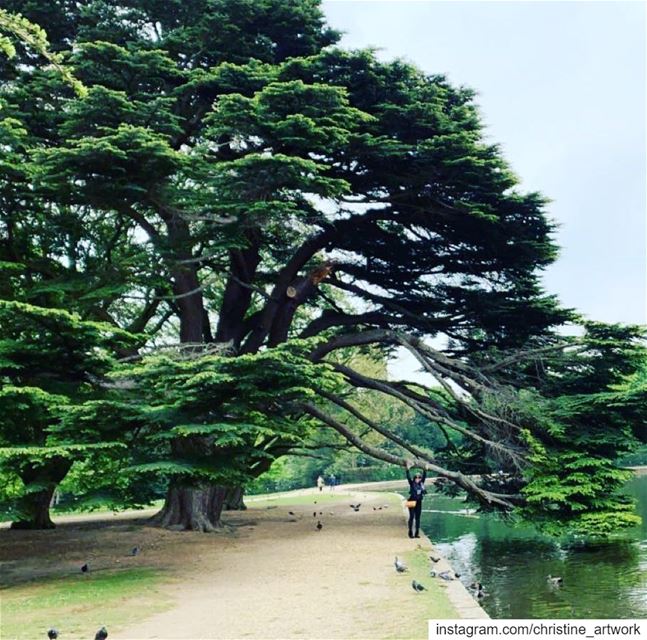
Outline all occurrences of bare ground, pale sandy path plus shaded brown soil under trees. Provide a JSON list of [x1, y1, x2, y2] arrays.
[[0, 491, 466, 640]]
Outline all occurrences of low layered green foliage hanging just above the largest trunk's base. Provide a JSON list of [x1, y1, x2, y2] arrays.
[[79, 341, 340, 492]]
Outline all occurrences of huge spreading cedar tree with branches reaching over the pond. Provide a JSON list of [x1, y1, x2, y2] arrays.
[[0, 0, 644, 533]]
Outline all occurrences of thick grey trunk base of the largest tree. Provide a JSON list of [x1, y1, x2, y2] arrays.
[[150, 482, 227, 532]]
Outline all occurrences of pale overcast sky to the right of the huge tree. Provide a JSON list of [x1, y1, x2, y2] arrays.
[[323, 0, 647, 375]]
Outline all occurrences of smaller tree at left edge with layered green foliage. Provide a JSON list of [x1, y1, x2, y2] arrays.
[[0, 299, 135, 523]]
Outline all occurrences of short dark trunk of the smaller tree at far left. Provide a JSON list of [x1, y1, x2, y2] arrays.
[[11, 459, 72, 529]]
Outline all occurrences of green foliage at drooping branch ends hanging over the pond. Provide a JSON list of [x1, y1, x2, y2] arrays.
[[466, 323, 647, 536]]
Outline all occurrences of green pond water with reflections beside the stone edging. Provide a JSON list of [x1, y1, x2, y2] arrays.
[[422, 476, 647, 618]]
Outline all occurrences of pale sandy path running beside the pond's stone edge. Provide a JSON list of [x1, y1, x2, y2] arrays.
[[111, 493, 456, 640]]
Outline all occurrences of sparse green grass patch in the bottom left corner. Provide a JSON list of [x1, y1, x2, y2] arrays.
[[0, 568, 172, 640]]
